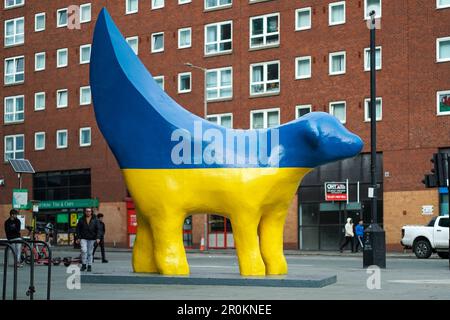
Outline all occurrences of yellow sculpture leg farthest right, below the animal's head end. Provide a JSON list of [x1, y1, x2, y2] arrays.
[[259, 212, 288, 275]]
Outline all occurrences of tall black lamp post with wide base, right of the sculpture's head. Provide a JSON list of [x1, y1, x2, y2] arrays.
[[363, 11, 386, 268]]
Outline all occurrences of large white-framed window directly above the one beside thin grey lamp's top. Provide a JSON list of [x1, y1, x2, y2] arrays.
[[205, 21, 233, 55]]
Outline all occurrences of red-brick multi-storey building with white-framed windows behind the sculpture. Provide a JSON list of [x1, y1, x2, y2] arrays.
[[0, 0, 450, 250]]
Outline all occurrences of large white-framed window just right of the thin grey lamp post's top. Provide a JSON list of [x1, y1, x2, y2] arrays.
[[206, 67, 233, 101]]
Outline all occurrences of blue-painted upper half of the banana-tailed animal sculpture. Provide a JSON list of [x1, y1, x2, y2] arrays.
[[90, 9, 363, 169]]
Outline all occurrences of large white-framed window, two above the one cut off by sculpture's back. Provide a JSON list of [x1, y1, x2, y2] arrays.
[[250, 13, 280, 48]]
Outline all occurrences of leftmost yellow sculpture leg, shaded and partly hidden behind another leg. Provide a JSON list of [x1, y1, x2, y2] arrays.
[[132, 214, 158, 273]]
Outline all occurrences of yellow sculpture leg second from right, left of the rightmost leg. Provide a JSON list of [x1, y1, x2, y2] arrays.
[[231, 216, 266, 276]]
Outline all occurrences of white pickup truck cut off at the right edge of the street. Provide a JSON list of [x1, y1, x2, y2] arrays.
[[400, 216, 450, 259]]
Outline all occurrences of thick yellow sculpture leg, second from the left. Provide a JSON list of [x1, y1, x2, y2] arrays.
[[150, 211, 189, 275]]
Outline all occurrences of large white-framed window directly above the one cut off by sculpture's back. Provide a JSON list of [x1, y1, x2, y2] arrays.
[[250, 61, 280, 95]]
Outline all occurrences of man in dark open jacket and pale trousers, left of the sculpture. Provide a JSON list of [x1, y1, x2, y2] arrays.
[[76, 208, 103, 272]]
